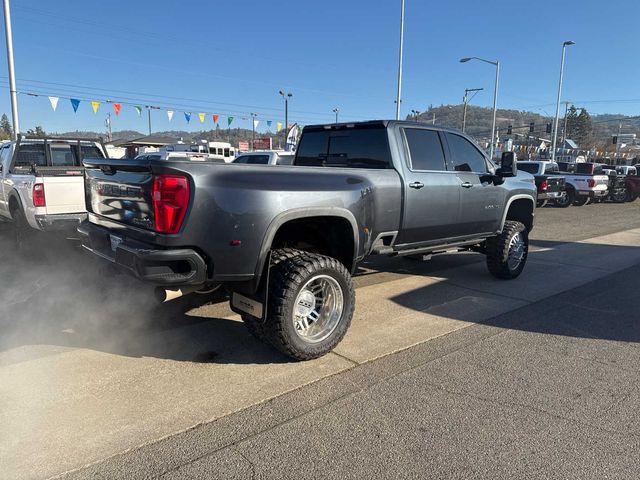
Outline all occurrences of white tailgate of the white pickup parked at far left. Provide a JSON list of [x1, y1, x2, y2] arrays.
[[36, 168, 86, 215]]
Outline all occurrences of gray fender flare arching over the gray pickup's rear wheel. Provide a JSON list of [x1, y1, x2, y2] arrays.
[[255, 207, 360, 285]]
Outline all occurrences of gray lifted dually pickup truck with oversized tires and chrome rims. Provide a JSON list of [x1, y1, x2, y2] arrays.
[[78, 121, 536, 360]]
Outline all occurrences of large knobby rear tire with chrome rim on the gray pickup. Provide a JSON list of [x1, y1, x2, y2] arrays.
[[264, 250, 355, 360]]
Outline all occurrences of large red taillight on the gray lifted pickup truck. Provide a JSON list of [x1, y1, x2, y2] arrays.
[[153, 175, 189, 233]]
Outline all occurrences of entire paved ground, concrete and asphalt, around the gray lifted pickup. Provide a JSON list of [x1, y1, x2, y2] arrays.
[[0, 202, 640, 478]]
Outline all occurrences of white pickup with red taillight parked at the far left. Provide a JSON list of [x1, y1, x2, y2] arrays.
[[0, 136, 107, 248]]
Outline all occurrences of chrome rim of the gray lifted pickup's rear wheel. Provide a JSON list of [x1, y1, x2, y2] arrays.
[[293, 275, 344, 343]]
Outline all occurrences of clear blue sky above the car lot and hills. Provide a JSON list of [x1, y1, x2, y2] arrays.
[[0, 0, 640, 132]]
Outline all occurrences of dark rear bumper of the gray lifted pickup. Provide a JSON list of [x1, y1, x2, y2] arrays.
[[78, 221, 207, 287]]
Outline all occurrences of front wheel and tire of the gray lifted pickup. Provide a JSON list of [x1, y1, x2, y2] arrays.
[[486, 220, 529, 280]]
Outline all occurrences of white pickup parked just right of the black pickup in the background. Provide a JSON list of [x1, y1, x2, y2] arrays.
[[556, 162, 609, 206]]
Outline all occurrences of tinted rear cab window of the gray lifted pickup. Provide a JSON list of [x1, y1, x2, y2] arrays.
[[295, 127, 391, 168]]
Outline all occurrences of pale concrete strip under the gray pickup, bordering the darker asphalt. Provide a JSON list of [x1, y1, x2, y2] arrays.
[[0, 230, 640, 478]]
